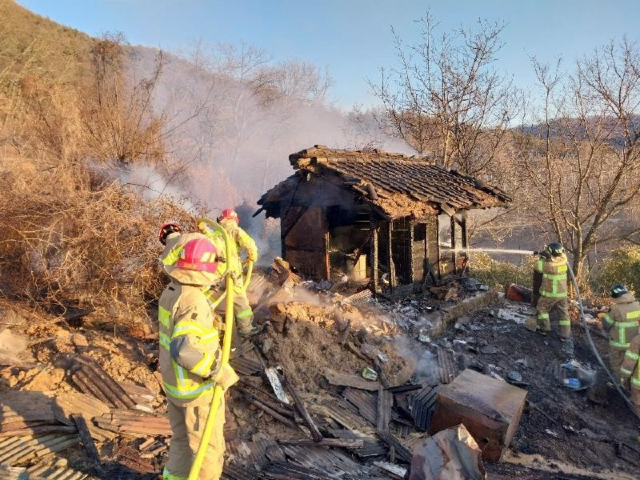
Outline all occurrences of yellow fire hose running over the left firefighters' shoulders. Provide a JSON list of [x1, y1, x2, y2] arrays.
[[188, 218, 233, 480]]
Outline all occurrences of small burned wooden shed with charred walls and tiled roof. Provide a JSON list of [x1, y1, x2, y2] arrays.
[[258, 145, 510, 293]]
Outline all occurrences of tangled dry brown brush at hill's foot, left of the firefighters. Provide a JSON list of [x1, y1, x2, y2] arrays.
[[0, 156, 192, 321]]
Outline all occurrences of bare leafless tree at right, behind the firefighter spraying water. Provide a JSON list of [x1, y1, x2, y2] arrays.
[[515, 39, 640, 284]]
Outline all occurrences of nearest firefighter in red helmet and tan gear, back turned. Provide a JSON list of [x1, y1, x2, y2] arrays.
[[158, 235, 238, 480]]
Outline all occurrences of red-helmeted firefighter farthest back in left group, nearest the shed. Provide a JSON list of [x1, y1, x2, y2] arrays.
[[199, 208, 260, 338]]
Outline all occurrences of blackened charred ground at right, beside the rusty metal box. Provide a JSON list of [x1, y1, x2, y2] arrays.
[[430, 300, 640, 478]]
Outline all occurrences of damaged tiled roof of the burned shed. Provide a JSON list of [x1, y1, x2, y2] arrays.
[[258, 146, 511, 218]]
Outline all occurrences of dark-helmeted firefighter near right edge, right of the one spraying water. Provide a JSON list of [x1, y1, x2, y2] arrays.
[[602, 284, 640, 382]]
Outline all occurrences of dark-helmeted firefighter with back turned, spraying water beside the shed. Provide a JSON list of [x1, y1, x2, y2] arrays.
[[535, 243, 571, 341]]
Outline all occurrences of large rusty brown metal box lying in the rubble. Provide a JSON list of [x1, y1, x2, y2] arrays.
[[429, 369, 527, 462]]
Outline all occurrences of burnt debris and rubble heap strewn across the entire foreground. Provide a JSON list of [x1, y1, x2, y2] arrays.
[[0, 263, 640, 480]]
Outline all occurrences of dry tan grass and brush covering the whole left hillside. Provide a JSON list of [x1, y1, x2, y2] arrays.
[[0, 0, 195, 323]]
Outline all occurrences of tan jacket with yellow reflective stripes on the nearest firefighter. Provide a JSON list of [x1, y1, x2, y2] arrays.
[[158, 282, 220, 406]]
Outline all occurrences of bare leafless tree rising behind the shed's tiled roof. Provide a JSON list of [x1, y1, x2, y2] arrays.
[[369, 14, 519, 175]]
